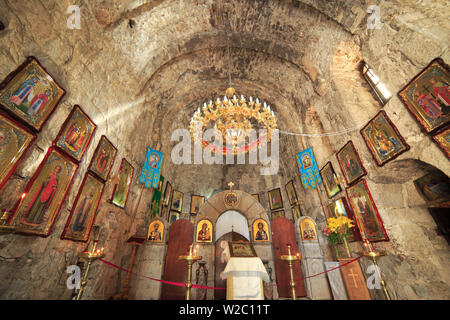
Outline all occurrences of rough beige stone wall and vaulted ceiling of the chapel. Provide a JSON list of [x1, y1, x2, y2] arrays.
[[0, 0, 450, 299]]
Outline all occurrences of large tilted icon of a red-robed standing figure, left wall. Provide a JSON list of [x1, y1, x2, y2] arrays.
[[9, 147, 78, 237]]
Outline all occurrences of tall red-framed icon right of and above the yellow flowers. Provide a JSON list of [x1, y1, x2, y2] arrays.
[[346, 179, 389, 242]]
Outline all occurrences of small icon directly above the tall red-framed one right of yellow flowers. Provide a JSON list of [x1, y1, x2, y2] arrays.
[[336, 141, 367, 185]]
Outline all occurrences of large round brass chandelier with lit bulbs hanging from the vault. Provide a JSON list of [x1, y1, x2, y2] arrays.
[[189, 41, 277, 155]]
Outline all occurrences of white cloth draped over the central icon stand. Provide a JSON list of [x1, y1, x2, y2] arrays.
[[221, 257, 270, 300]]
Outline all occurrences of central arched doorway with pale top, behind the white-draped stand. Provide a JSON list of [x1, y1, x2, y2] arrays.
[[214, 210, 250, 300]]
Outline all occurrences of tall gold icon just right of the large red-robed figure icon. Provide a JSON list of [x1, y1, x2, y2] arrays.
[[61, 173, 104, 242]]
